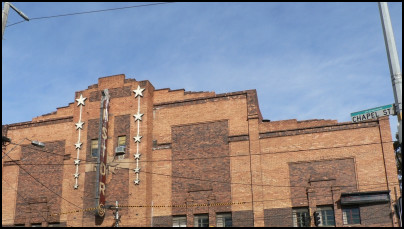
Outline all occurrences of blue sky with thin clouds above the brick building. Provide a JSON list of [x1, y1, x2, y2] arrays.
[[2, 2, 402, 138]]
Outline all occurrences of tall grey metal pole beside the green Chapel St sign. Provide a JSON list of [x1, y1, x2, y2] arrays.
[[379, 2, 403, 148]]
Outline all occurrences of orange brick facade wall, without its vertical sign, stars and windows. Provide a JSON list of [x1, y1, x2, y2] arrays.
[[2, 75, 397, 227]]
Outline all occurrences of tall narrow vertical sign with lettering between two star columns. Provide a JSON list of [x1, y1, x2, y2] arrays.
[[95, 89, 110, 217]]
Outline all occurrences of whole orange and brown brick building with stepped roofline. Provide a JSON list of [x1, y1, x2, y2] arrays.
[[2, 75, 400, 227]]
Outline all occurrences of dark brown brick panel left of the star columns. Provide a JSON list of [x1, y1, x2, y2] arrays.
[[15, 141, 65, 224]]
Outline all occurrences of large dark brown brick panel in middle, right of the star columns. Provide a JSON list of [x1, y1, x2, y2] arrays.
[[172, 121, 231, 225]]
